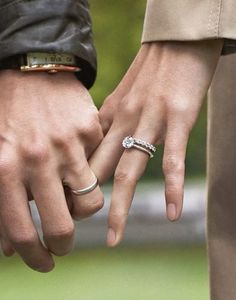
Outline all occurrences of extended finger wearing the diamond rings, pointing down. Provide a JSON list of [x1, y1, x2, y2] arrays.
[[107, 129, 156, 246]]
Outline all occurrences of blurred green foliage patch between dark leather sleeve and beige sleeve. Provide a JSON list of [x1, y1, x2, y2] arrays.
[[90, 0, 145, 106]]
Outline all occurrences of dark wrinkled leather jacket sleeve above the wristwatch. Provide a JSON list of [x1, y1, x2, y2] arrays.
[[0, 0, 97, 88]]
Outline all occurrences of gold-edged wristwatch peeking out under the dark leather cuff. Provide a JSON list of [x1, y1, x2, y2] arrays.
[[0, 52, 81, 74]]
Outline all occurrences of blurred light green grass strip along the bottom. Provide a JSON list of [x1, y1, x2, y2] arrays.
[[0, 247, 208, 300]]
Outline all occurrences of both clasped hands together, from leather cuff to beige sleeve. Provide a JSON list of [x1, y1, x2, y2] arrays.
[[0, 40, 222, 272]]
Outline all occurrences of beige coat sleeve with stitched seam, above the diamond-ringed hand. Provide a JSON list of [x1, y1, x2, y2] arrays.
[[142, 0, 236, 53]]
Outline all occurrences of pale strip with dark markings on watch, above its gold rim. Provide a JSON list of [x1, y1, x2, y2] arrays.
[[27, 52, 76, 66]]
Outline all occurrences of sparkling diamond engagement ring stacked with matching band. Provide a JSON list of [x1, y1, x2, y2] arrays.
[[122, 136, 157, 158]]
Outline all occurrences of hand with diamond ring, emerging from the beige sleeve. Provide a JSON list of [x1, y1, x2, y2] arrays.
[[90, 40, 222, 246]]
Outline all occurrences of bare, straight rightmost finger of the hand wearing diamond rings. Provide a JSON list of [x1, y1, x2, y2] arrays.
[[163, 125, 189, 221]]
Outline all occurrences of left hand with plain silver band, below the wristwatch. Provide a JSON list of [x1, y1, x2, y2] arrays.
[[0, 71, 103, 272]]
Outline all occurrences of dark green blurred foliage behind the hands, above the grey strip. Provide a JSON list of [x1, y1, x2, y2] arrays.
[[90, 0, 206, 179]]
